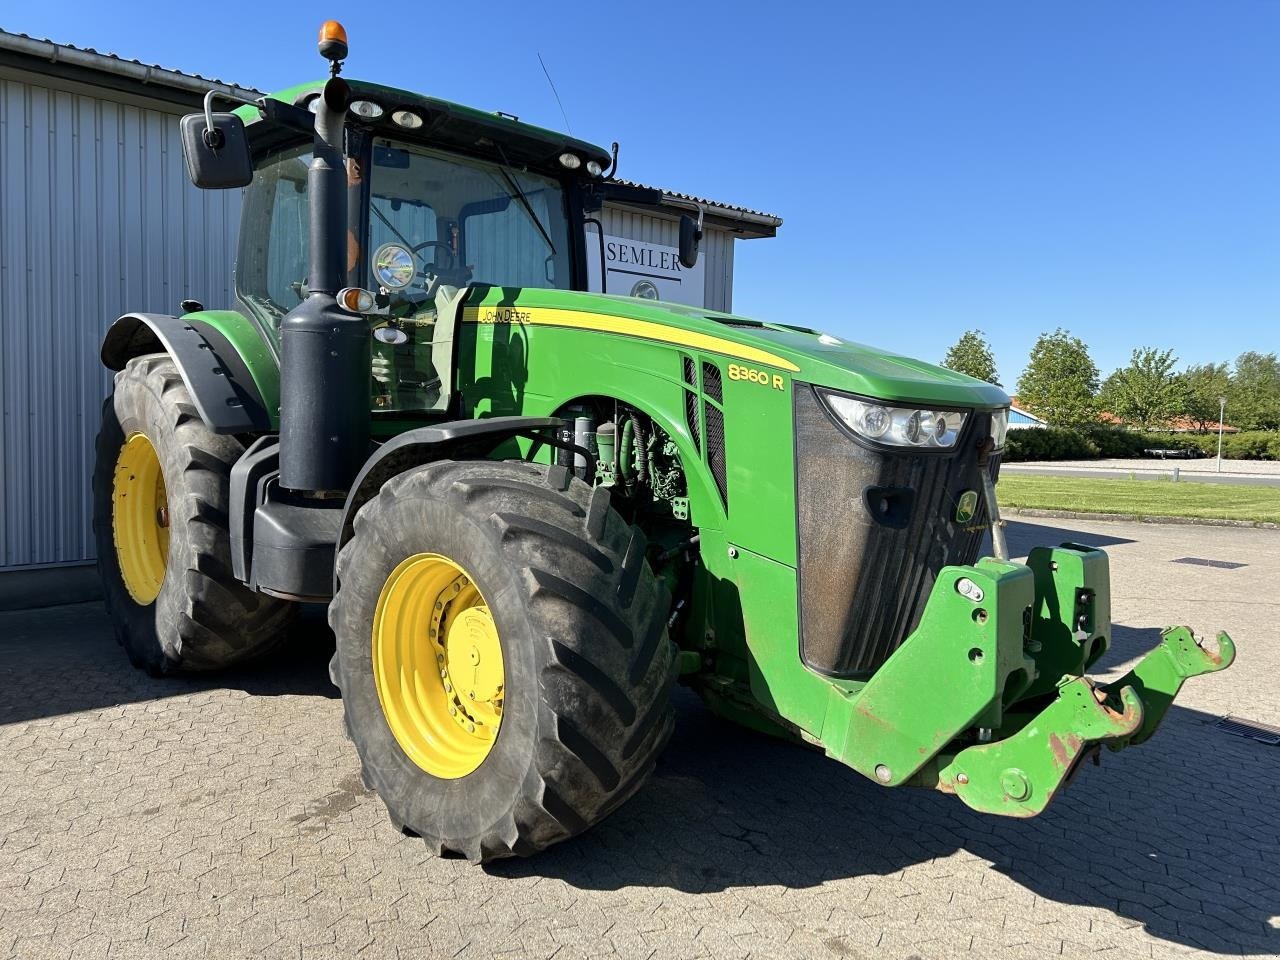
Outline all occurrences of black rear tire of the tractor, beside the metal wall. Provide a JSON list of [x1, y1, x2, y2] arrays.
[[93, 353, 297, 675]]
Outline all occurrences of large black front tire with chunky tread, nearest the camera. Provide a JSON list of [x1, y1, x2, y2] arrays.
[[329, 461, 675, 861]]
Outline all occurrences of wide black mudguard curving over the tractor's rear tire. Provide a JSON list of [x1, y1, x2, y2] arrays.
[[101, 311, 275, 434]]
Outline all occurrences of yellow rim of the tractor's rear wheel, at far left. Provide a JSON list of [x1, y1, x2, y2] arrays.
[[111, 434, 169, 607]]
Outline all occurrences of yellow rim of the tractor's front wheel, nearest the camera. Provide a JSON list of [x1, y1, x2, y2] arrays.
[[374, 553, 504, 780]]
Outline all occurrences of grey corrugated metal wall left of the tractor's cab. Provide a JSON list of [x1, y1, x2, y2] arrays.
[[0, 79, 241, 568]]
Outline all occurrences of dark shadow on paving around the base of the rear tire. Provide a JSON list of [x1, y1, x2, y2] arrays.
[[0, 603, 338, 723]]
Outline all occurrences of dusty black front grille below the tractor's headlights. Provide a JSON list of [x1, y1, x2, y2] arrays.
[[795, 383, 1000, 677]]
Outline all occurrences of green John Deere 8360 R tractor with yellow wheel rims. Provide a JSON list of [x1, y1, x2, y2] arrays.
[[93, 22, 1234, 861]]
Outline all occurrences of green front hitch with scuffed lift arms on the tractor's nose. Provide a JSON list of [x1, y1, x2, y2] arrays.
[[822, 544, 1235, 817]]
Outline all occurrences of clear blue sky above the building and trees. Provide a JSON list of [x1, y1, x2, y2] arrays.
[[12, 0, 1280, 389]]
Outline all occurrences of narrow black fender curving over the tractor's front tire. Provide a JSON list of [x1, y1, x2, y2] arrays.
[[333, 416, 568, 590]]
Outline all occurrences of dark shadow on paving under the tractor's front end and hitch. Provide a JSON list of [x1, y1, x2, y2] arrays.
[[496, 647, 1280, 955]]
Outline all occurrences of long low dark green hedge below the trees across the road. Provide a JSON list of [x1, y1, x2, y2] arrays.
[[1005, 426, 1280, 463]]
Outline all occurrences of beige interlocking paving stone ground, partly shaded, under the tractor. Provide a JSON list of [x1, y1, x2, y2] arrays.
[[0, 521, 1280, 960]]
